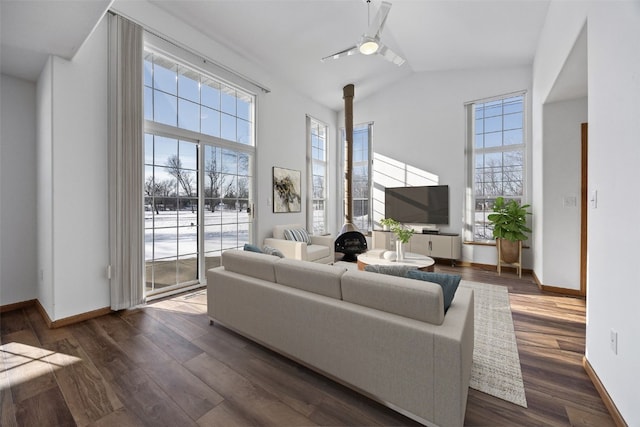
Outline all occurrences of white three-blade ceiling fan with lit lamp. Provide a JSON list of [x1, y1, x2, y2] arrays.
[[322, 0, 405, 66]]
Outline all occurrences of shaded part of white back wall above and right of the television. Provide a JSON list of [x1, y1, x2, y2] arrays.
[[348, 66, 535, 267]]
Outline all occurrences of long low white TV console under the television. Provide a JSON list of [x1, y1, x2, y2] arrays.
[[372, 230, 462, 265]]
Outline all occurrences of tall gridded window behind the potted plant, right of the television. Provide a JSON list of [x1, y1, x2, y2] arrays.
[[467, 93, 526, 241]]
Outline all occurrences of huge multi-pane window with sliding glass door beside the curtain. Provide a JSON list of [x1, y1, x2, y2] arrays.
[[144, 47, 255, 295]]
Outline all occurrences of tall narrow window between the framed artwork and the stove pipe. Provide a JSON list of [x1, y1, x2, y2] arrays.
[[307, 116, 328, 235]]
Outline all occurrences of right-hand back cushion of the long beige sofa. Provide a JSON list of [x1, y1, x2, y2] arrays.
[[342, 270, 444, 325]]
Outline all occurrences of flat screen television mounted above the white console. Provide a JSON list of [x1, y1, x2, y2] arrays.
[[384, 185, 449, 225]]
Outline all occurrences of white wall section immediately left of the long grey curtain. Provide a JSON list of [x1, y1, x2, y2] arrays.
[[38, 20, 110, 321]]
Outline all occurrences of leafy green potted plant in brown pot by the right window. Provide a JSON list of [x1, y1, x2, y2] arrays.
[[487, 197, 531, 264]]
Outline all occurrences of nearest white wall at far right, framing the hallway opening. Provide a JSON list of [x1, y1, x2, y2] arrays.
[[534, 1, 640, 426]]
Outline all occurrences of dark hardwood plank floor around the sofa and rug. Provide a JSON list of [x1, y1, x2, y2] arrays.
[[0, 264, 614, 427]]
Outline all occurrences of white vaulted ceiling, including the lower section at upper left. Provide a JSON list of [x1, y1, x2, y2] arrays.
[[0, 0, 549, 110]]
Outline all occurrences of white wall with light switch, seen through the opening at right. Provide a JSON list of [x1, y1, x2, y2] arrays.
[[538, 98, 587, 290]]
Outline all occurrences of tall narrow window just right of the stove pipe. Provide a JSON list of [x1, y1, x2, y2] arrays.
[[342, 123, 373, 233]]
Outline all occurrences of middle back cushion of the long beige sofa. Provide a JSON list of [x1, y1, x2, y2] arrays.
[[275, 258, 347, 299]]
